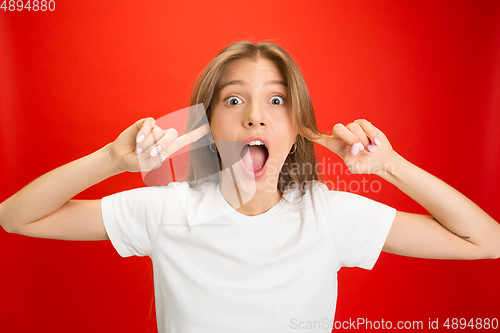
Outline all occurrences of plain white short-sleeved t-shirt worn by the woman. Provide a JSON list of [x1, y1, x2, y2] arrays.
[[102, 181, 396, 333]]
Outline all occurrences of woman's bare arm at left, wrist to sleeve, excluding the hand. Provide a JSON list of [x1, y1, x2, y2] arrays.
[[0, 144, 124, 239]]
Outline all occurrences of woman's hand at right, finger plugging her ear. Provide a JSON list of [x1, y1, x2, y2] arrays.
[[303, 119, 394, 175]]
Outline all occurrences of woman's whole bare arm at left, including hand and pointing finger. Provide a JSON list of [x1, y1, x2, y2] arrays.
[[0, 118, 209, 240]]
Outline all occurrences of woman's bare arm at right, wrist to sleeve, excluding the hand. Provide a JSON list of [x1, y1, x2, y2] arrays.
[[377, 152, 500, 259]]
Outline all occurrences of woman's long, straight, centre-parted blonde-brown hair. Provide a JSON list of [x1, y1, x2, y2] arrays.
[[186, 40, 321, 196]]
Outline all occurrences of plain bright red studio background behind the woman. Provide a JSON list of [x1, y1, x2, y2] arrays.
[[0, 0, 500, 333]]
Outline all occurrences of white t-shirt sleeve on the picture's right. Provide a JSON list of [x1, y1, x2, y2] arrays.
[[328, 191, 396, 269]]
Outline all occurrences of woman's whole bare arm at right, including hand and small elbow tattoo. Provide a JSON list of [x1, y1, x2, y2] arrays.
[[303, 119, 500, 259]]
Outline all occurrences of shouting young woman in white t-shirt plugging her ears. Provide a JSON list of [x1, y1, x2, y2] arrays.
[[0, 41, 500, 333]]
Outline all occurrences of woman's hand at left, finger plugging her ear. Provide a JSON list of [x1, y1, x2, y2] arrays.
[[109, 117, 210, 172]]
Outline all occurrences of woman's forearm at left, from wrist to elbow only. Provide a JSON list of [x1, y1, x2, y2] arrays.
[[0, 144, 121, 229]]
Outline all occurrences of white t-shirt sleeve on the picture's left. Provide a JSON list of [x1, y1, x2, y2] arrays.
[[101, 184, 180, 257]]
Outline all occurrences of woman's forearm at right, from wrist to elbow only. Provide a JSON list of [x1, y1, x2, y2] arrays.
[[378, 152, 500, 249]]
